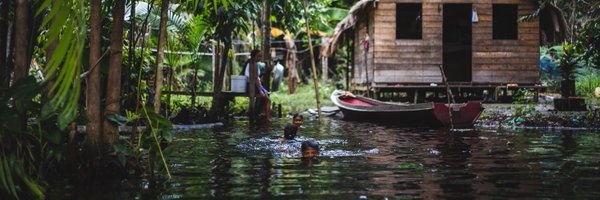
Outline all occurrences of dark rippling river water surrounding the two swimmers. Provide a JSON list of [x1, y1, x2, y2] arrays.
[[49, 119, 600, 199]]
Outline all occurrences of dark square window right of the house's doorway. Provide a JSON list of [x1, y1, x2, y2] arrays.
[[492, 4, 519, 40]]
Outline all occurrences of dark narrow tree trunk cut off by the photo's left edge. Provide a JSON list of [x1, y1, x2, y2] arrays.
[[0, 1, 9, 89]]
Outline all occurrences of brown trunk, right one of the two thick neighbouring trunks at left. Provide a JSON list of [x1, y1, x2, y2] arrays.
[[103, 0, 125, 146]]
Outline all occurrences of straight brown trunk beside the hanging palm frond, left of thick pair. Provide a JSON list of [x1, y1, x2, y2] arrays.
[[86, 0, 102, 151]]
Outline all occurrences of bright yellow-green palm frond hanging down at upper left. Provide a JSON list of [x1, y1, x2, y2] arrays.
[[37, 0, 87, 130]]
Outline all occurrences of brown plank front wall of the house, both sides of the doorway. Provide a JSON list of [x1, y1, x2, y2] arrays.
[[354, 0, 539, 84]]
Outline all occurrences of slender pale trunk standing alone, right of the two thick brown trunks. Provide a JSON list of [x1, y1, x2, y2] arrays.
[[154, 0, 169, 114]]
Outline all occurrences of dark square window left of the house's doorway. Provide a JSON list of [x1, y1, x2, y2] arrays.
[[396, 3, 423, 39]]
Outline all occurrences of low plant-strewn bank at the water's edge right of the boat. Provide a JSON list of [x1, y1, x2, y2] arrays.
[[475, 104, 600, 129]]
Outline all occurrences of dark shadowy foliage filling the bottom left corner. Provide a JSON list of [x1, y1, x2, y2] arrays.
[[0, 76, 63, 199]]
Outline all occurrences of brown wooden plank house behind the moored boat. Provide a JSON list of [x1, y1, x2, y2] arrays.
[[324, 0, 543, 101]]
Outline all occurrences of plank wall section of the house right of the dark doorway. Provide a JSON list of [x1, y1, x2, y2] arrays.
[[473, 0, 540, 84]]
